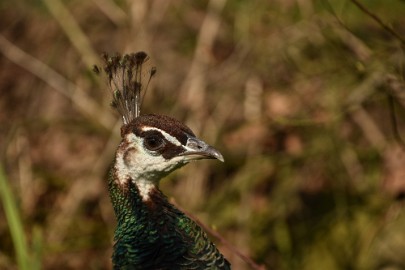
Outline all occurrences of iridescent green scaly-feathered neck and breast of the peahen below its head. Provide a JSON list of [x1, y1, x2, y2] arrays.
[[109, 161, 230, 269]]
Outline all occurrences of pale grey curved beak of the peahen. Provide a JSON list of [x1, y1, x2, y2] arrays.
[[180, 138, 224, 162]]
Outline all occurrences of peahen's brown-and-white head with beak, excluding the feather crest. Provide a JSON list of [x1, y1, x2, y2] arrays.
[[115, 114, 224, 197]]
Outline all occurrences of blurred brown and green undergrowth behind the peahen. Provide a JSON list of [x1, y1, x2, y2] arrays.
[[0, 0, 405, 270]]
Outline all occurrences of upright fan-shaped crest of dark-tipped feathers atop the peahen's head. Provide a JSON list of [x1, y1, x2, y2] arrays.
[[94, 52, 156, 124]]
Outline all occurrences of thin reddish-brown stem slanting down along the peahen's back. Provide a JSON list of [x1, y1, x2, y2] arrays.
[[172, 200, 266, 270]]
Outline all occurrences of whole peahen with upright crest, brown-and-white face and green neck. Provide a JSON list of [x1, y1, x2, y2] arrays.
[[95, 52, 230, 269]]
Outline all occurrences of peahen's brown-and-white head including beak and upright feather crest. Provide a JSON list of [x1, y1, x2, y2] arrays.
[[94, 52, 224, 198]]
